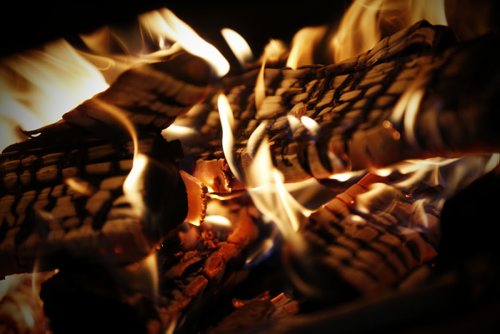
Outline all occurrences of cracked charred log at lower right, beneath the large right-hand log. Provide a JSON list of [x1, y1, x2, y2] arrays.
[[286, 174, 439, 303]]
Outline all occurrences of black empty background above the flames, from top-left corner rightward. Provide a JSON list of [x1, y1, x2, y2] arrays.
[[0, 0, 350, 56]]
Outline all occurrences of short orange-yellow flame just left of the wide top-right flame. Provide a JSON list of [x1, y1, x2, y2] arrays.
[[286, 26, 327, 69]]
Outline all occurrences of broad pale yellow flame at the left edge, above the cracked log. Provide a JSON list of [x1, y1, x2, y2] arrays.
[[0, 40, 108, 149]]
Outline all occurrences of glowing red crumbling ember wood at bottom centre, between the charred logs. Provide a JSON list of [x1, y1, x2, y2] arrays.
[[158, 199, 260, 328]]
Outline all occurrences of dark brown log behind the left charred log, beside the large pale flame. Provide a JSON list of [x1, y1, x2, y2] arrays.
[[58, 53, 211, 136]]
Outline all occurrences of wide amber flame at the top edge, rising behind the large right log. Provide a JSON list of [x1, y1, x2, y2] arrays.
[[330, 0, 447, 62]]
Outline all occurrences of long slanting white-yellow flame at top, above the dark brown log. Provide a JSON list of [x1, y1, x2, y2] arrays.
[[140, 8, 229, 77]]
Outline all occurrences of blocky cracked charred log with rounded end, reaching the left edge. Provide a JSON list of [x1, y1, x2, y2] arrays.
[[0, 135, 187, 276]]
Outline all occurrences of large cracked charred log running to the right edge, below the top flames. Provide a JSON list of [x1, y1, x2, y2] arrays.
[[178, 22, 500, 190]]
